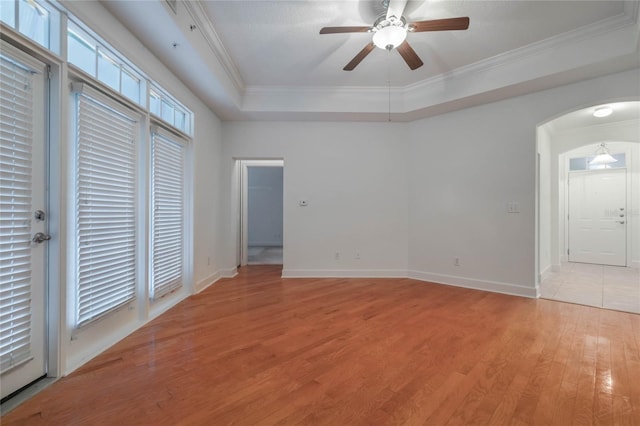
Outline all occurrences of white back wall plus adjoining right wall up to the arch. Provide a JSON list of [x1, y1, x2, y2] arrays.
[[222, 70, 640, 296]]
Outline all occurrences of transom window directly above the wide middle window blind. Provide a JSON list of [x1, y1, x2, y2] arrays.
[[67, 22, 145, 106]]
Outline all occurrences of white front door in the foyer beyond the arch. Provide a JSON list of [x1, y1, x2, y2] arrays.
[[569, 169, 627, 266]]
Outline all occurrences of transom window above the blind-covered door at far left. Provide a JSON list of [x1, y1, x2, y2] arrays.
[[0, 0, 60, 53]]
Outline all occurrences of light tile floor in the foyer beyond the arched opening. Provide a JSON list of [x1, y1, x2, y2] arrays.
[[540, 263, 640, 314]]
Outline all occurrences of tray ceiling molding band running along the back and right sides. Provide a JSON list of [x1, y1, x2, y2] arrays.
[[241, 5, 640, 120]]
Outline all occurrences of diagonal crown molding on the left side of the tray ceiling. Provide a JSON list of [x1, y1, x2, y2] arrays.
[[182, 1, 246, 93]]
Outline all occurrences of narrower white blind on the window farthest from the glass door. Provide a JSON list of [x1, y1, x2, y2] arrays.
[[150, 133, 185, 299]]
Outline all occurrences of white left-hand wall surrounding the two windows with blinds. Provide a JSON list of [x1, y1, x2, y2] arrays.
[[53, 2, 228, 373]]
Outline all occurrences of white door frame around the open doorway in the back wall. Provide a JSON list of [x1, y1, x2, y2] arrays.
[[236, 158, 286, 267]]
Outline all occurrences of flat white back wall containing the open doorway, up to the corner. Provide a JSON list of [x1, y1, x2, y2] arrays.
[[223, 122, 407, 276]]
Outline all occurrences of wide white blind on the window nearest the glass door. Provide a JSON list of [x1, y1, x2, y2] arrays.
[[76, 93, 138, 326]]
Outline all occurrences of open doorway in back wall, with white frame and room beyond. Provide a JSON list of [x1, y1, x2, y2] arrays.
[[239, 160, 284, 266]]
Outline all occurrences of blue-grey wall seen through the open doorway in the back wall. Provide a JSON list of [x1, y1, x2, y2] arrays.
[[247, 166, 284, 247]]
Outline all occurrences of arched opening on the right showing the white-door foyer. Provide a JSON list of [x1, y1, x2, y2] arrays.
[[535, 101, 640, 313]]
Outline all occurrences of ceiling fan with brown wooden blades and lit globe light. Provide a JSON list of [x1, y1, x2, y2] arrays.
[[320, 0, 469, 71]]
